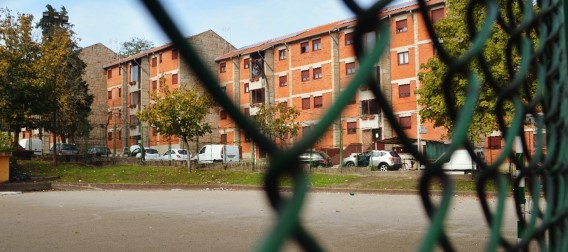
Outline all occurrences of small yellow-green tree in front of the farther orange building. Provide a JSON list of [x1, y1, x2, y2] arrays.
[[136, 86, 215, 170]]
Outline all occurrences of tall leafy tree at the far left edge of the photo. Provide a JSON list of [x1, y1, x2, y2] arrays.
[[0, 9, 47, 149]]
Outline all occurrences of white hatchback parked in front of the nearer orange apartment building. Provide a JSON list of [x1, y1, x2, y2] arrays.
[[343, 150, 402, 171]]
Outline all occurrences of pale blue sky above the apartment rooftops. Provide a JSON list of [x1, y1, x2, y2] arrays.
[[0, 0, 382, 52]]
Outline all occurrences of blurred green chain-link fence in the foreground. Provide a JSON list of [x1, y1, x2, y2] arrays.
[[143, 0, 568, 251]]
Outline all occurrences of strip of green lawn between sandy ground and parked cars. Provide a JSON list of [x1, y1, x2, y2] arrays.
[[16, 160, 504, 192]]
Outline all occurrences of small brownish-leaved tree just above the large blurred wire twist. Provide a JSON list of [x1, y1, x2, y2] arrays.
[[255, 103, 300, 146]]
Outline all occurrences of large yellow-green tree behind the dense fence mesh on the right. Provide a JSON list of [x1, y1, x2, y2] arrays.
[[416, 0, 534, 141]]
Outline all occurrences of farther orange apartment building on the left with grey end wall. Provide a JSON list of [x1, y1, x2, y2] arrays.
[[104, 30, 235, 153]]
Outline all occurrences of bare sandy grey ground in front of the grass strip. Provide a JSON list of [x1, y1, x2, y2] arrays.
[[0, 190, 516, 251]]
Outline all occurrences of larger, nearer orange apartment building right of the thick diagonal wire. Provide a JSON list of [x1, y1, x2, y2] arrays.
[[216, 1, 445, 161]]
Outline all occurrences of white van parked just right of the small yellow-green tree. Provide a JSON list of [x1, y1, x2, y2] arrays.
[[195, 144, 240, 164]]
